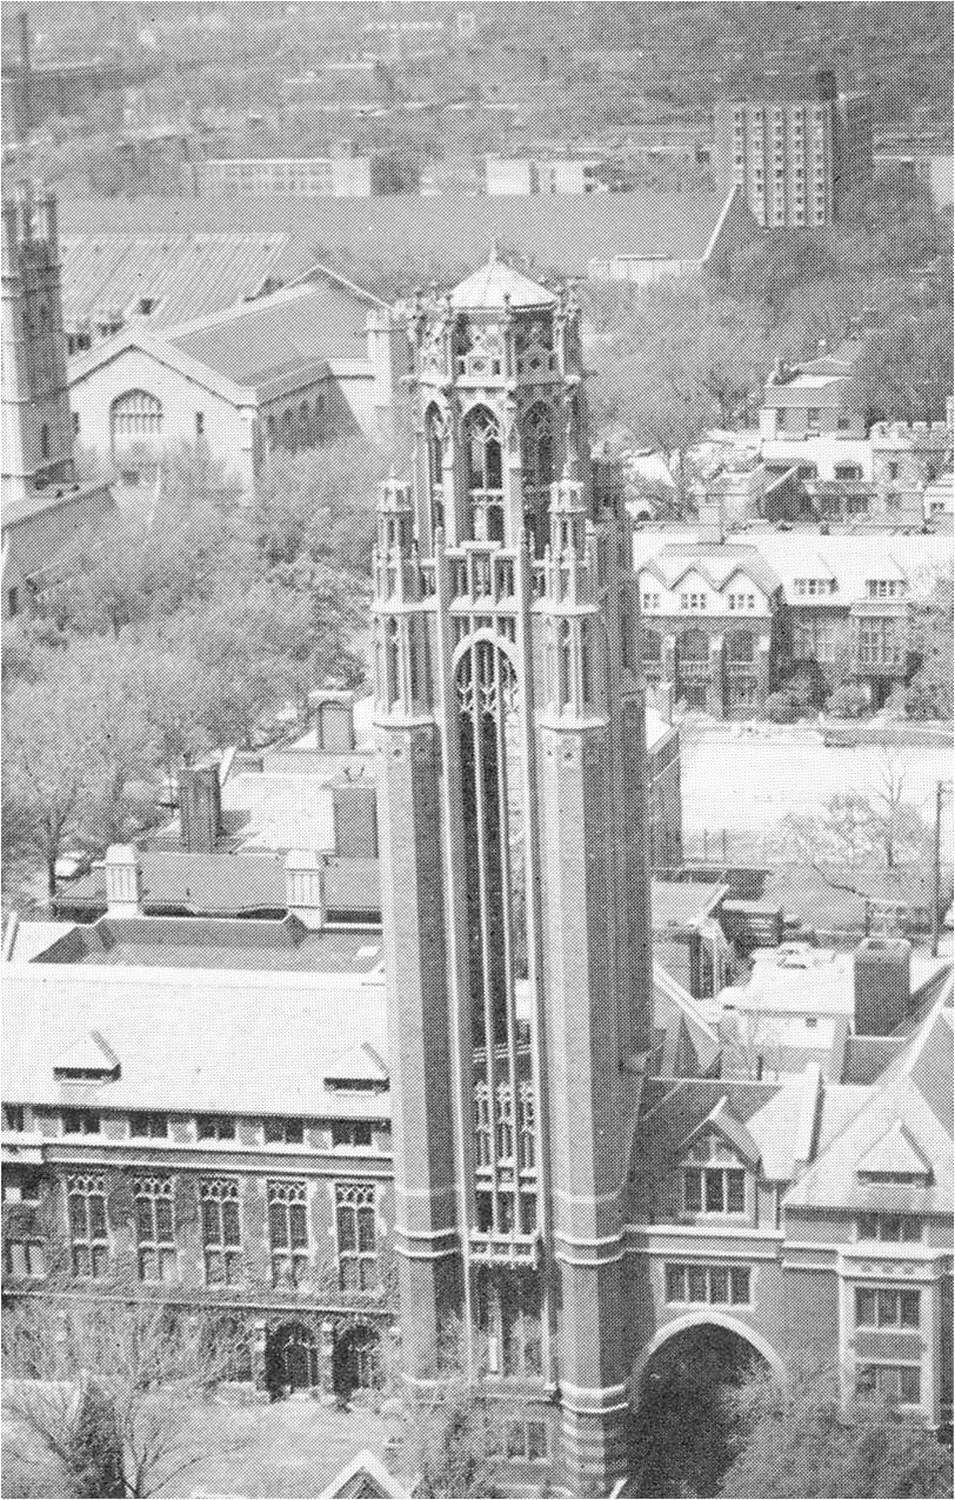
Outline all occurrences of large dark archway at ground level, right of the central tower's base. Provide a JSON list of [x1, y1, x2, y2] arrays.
[[631, 1319, 778, 1496]]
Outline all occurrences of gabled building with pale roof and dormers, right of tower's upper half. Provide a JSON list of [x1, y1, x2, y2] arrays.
[[634, 519, 951, 719]]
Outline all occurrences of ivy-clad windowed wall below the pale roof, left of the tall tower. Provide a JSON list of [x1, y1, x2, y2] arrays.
[[3, 1101, 397, 1397]]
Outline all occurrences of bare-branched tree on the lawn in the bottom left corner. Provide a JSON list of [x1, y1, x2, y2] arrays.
[[3, 1301, 247, 1497]]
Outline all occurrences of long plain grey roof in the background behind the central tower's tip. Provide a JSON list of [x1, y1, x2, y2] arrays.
[[60, 191, 740, 282]]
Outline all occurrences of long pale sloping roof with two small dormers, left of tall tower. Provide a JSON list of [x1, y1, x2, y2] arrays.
[[3, 965, 388, 1119]]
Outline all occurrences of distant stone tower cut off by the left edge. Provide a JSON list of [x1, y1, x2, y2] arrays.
[[3, 185, 73, 504]]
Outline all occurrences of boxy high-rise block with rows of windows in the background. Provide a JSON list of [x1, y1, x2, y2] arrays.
[[714, 72, 873, 230]]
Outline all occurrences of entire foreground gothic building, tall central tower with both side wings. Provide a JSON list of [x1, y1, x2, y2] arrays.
[[3, 261, 952, 1496]]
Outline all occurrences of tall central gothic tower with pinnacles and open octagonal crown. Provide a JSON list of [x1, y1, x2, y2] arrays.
[[368, 257, 652, 1496]]
